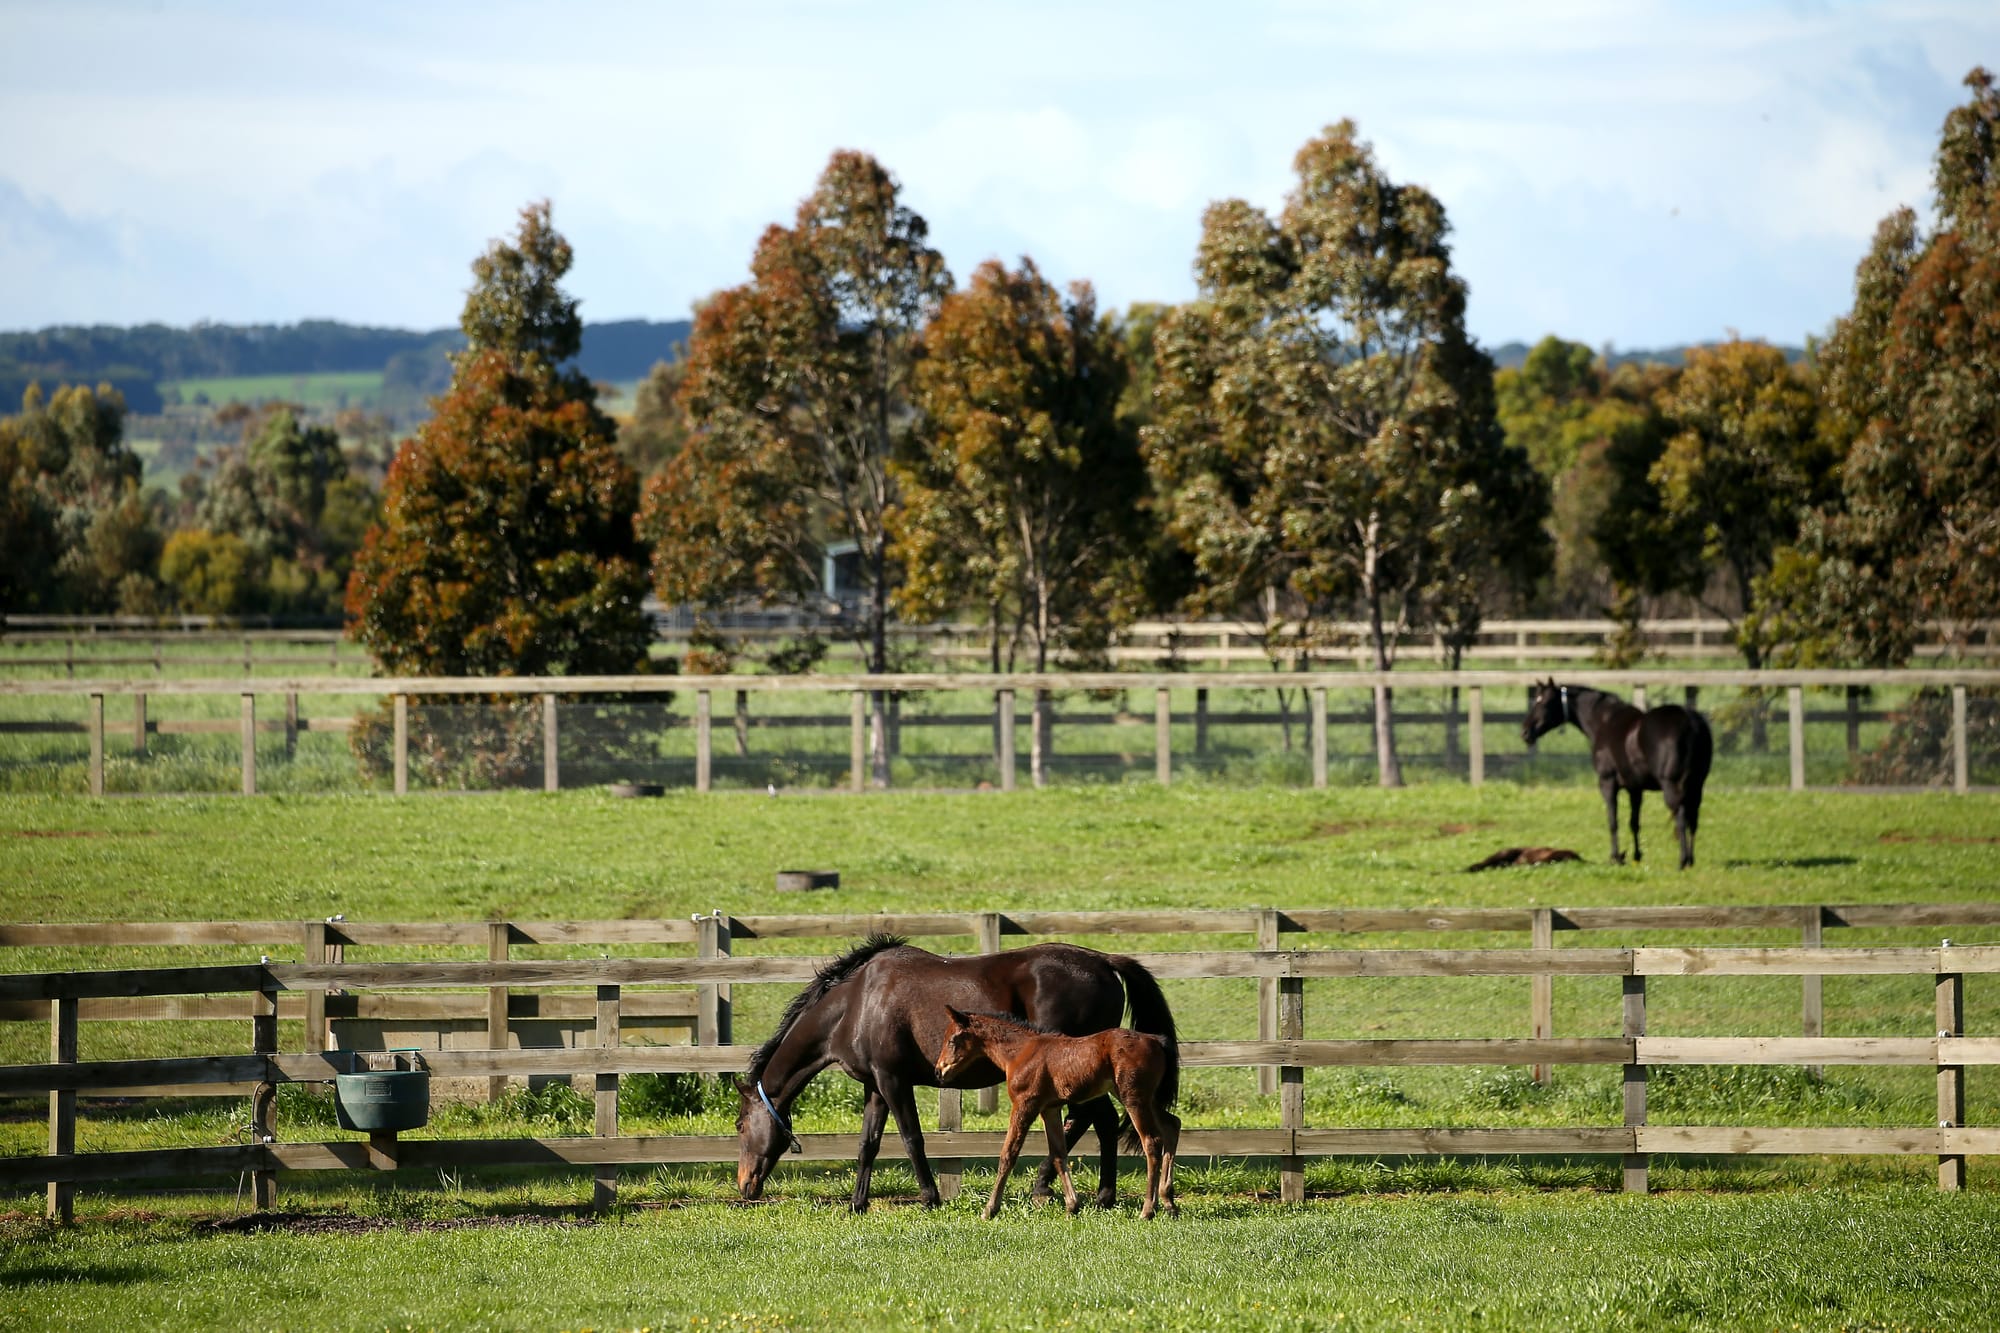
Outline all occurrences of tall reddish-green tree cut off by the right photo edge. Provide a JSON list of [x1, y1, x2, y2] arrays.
[[1762, 68, 2000, 664]]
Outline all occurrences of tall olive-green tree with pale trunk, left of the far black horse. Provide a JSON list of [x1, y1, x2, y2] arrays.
[[1144, 122, 1546, 787]]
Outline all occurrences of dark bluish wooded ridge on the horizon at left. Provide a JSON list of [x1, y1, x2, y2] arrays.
[[0, 320, 690, 414]]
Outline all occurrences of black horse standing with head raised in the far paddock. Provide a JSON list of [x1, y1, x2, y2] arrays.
[[1520, 679, 1714, 871]]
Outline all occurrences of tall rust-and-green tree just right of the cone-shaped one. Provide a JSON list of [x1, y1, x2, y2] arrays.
[[642, 152, 952, 785]]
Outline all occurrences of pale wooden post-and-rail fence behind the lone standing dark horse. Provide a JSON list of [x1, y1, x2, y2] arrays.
[[0, 669, 2000, 797]]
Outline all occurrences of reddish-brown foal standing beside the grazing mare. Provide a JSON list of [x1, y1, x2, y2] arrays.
[[938, 1005, 1180, 1219]]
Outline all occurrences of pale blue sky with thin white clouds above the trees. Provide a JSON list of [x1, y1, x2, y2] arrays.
[[0, 0, 2000, 346]]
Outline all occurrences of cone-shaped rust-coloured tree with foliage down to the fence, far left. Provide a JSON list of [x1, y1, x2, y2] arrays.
[[348, 202, 648, 677]]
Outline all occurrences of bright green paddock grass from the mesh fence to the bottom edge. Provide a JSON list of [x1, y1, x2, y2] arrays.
[[0, 783, 2000, 1327]]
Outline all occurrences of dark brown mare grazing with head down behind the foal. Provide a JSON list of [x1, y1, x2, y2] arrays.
[[736, 935, 1180, 1213]]
